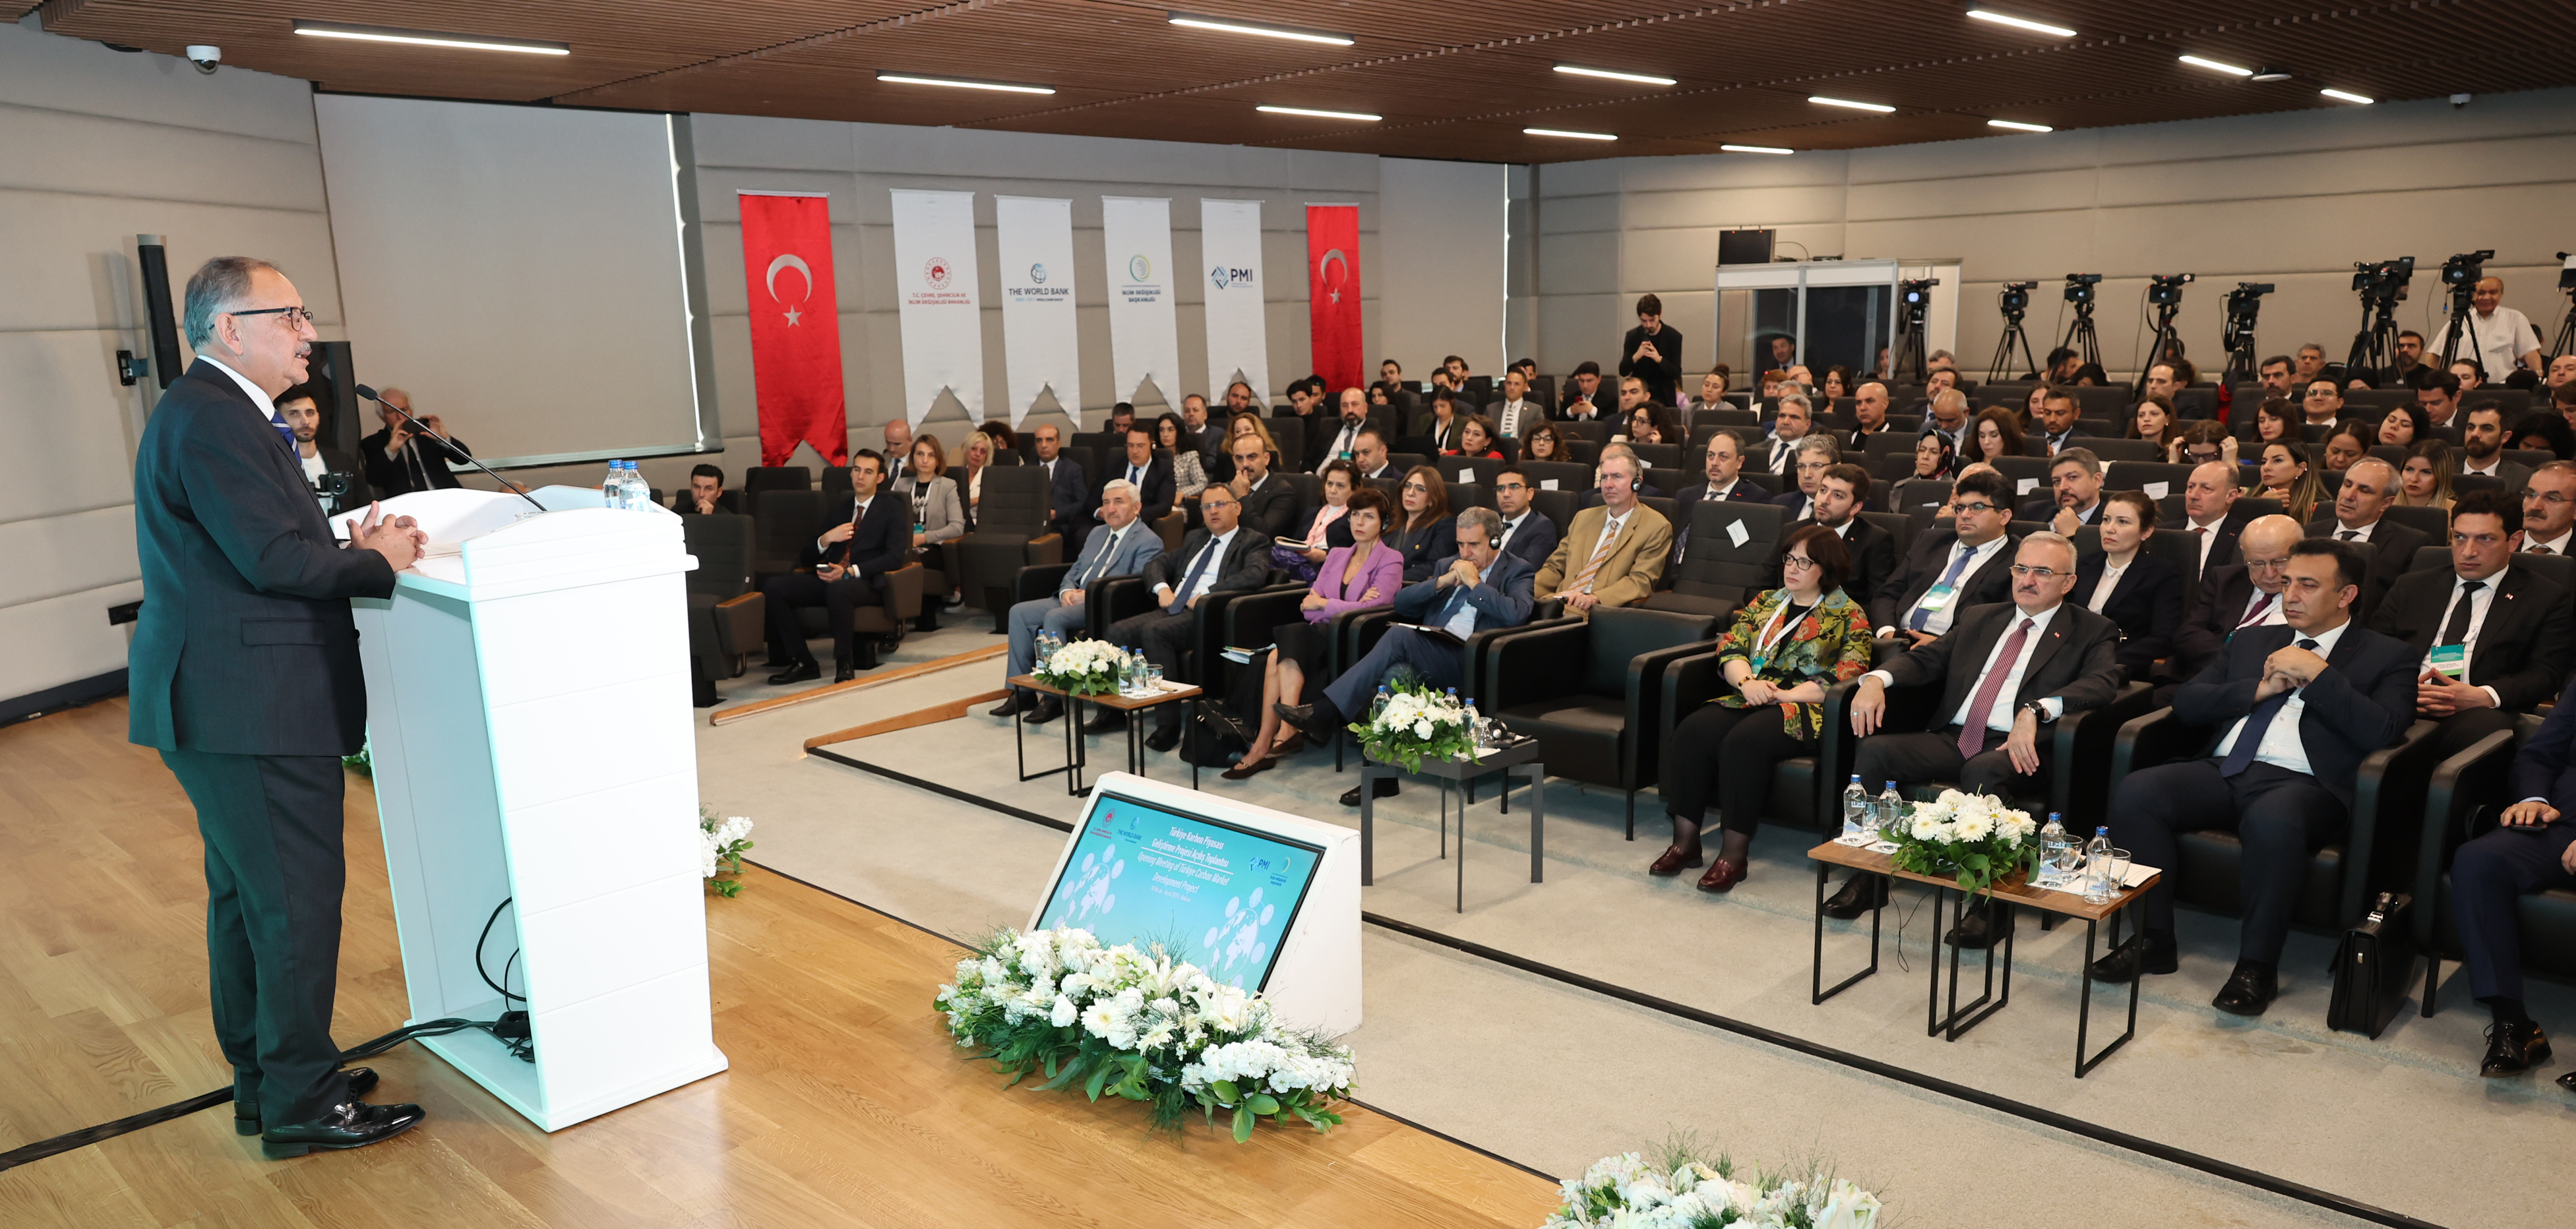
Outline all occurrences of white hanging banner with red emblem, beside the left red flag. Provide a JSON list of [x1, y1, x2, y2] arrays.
[[894, 188, 984, 428]]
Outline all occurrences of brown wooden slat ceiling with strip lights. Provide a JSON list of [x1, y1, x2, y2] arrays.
[[41, 0, 2576, 162]]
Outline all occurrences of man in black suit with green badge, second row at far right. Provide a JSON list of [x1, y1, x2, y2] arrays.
[[2370, 489, 2576, 760]]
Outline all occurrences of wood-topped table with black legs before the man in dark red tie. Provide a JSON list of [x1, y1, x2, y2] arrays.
[[1806, 840, 2164, 1079]]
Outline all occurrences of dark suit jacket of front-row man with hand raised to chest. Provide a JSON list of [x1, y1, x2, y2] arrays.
[[2174, 626, 2416, 809]]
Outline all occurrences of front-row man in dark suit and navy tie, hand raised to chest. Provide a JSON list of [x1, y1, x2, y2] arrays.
[[2095, 539, 2416, 1015]]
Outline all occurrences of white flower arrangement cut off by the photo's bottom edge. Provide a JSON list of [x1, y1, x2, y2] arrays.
[[1541, 1147, 1880, 1229]]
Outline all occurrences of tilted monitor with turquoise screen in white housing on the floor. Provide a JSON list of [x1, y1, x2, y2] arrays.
[[1027, 773, 1360, 1036]]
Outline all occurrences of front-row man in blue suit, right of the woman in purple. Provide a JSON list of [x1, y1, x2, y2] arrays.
[[1280, 508, 1538, 806]]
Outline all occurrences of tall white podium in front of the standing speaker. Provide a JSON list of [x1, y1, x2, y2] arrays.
[[353, 487, 726, 1131]]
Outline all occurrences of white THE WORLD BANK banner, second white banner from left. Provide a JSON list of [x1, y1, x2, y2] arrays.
[[992, 196, 1082, 428]]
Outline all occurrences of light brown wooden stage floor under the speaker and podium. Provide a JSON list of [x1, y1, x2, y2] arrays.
[[0, 701, 1556, 1229]]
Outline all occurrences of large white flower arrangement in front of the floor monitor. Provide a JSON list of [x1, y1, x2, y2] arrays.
[[935, 928, 1353, 1144]]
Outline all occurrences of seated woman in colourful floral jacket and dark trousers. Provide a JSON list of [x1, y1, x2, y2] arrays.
[[1651, 525, 1870, 891]]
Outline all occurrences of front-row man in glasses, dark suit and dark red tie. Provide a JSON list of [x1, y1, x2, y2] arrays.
[[1824, 533, 2120, 932]]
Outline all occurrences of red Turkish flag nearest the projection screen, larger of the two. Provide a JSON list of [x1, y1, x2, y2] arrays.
[[737, 193, 850, 466]]
